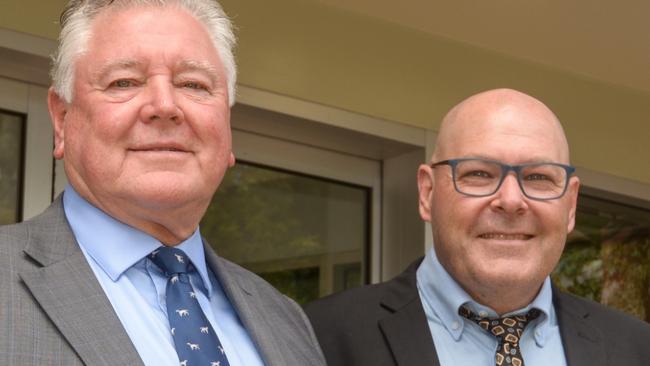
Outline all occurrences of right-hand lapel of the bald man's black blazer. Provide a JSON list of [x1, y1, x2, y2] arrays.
[[553, 287, 607, 366]]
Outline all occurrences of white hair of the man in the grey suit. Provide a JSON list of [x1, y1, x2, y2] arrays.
[[50, 0, 237, 106]]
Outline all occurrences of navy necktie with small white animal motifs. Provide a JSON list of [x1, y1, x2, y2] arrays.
[[149, 247, 230, 366]]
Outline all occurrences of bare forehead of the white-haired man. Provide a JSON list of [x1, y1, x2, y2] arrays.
[[78, 5, 221, 77]]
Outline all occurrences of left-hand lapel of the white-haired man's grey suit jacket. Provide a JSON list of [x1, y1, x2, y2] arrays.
[[20, 198, 142, 365]]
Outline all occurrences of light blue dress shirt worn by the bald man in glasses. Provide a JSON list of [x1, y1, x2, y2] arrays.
[[417, 249, 566, 366]]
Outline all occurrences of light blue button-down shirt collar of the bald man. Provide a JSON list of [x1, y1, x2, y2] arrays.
[[416, 248, 557, 347]]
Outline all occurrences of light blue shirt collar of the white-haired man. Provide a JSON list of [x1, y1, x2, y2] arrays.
[[63, 185, 212, 296]]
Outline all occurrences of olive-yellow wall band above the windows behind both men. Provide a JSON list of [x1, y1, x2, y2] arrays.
[[0, 0, 650, 184]]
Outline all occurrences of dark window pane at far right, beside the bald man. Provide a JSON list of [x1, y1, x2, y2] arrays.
[[552, 195, 650, 322]]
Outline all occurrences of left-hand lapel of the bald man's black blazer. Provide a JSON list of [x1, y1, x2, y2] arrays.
[[379, 261, 440, 366]]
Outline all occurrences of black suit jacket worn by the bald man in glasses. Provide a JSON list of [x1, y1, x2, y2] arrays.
[[305, 259, 650, 366]]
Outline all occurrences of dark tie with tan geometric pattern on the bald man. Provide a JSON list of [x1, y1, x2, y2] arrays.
[[458, 306, 541, 366]]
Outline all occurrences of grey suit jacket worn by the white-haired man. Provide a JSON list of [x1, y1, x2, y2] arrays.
[[0, 197, 325, 366]]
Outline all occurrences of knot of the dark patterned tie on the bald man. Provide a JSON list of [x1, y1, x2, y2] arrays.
[[458, 306, 541, 343]]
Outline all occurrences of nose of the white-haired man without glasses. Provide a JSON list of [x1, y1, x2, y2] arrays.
[[141, 80, 184, 124]]
